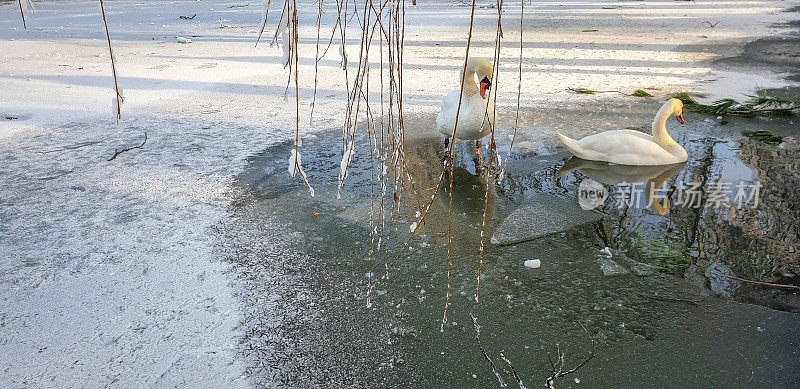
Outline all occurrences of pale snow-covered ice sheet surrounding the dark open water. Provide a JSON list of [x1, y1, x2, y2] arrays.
[[0, 0, 784, 387]]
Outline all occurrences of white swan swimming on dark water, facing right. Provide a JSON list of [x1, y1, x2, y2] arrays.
[[558, 99, 689, 166]]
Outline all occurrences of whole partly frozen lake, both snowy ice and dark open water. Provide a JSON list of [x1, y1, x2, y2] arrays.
[[0, 0, 800, 388]]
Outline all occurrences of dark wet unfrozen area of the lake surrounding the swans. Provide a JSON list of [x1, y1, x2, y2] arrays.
[[221, 109, 800, 387]]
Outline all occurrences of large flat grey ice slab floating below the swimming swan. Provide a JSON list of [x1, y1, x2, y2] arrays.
[[491, 195, 603, 244]]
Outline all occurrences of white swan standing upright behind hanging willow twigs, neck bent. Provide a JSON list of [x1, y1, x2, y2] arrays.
[[436, 58, 495, 170]]
